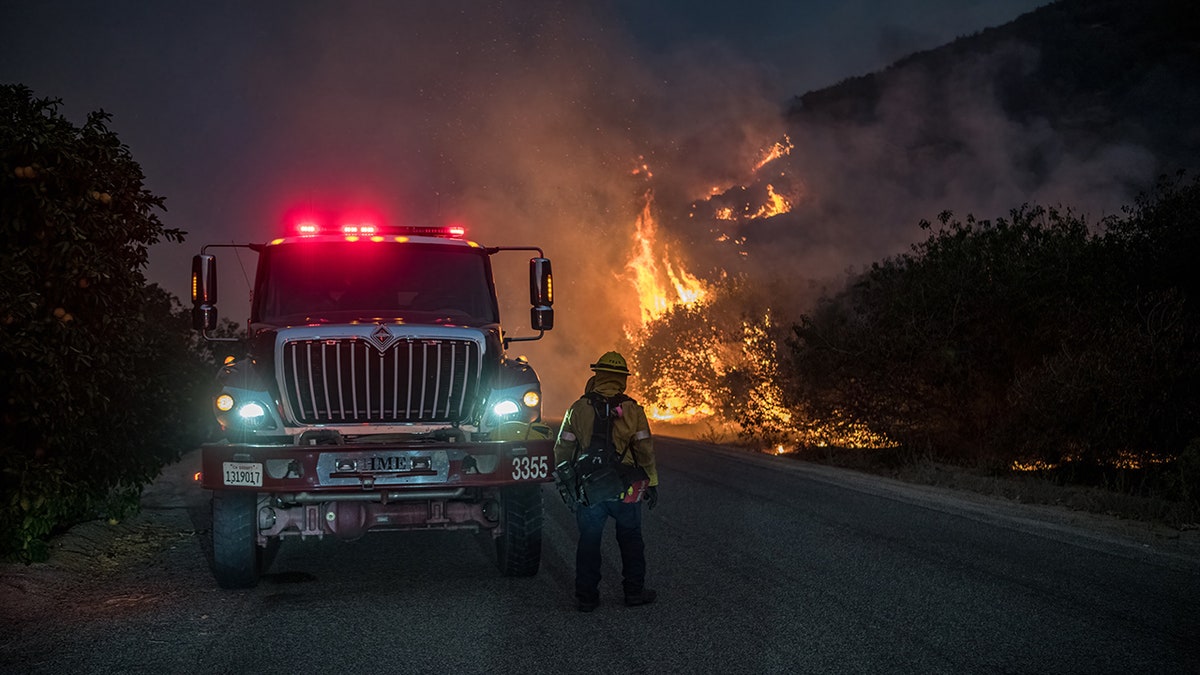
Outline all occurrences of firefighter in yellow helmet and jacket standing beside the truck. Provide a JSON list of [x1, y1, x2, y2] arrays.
[[554, 352, 659, 611]]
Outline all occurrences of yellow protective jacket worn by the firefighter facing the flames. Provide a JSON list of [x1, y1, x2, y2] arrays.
[[554, 371, 659, 486]]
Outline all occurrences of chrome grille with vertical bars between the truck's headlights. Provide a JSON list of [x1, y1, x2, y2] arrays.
[[280, 338, 481, 424]]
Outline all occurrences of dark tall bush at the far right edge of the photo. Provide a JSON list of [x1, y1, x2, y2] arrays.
[[1009, 172, 1200, 466]]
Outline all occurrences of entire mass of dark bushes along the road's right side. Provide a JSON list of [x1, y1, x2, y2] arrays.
[[785, 172, 1200, 478]]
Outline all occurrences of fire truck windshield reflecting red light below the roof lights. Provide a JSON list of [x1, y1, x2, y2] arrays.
[[252, 241, 499, 325]]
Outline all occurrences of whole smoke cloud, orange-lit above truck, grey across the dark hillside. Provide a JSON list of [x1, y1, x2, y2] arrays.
[[145, 2, 1150, 418]]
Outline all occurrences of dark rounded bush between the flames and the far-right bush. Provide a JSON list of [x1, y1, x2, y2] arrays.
[[791, 208, 1087, 450]]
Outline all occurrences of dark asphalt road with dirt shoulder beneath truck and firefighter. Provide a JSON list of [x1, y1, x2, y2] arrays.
[[0, 438, 1200, 674]]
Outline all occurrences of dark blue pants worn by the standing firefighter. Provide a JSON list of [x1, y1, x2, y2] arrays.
[[575, 502, 646, 602]]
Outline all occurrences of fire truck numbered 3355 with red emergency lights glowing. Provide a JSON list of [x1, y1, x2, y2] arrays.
[[192, 221, 554, 589]]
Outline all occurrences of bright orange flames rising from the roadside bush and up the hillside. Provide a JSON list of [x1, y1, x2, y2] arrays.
[[625, 142, 889, 446]]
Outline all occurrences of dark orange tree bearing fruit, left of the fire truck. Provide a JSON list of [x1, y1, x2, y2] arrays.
[[0, 85, 212, 561]]
